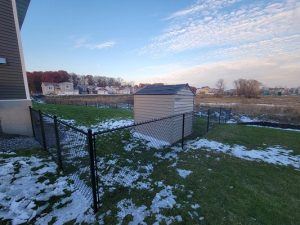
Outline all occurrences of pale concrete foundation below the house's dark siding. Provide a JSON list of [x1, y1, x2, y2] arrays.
[[0, 99, 32, 136]]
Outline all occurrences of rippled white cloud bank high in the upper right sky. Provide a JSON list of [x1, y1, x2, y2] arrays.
[[142, 0, 300, 55]]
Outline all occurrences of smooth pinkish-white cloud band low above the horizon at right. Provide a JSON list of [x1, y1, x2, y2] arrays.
[[140, 51, 300, 88]]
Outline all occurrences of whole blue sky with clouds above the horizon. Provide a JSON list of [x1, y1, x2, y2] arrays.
[[22, 0, 300, 88]]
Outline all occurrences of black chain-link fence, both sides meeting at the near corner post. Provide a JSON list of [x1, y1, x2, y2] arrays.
[[30, 108, 229, 212]]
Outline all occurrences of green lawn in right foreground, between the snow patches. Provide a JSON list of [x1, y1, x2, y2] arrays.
[[97, 122, 300, 225]]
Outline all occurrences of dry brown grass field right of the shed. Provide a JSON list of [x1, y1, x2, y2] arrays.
[[195, 96, 300, 124]]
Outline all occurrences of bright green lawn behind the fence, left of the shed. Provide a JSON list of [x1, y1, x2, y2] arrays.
[[33, 103, 133, 126]]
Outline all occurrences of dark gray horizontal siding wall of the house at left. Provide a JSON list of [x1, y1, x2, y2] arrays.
[[0, 0, 26, 100]]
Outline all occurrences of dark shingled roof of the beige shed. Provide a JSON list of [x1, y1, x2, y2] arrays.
[[135, 84, 193, 95]]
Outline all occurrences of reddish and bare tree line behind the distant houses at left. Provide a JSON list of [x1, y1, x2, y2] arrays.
[[27, 70, 133, 94]]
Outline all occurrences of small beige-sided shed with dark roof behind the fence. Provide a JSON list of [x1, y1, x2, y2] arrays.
[[134, 84, 195, 144]]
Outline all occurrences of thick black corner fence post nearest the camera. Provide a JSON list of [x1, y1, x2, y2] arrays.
[[87, 129, 98, 213]]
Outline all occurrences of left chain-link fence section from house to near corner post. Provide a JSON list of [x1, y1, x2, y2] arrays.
[[30, 108, 94, 207]]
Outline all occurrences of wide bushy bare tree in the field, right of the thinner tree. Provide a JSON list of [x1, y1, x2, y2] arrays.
[[233, 79, 261, 98]]
